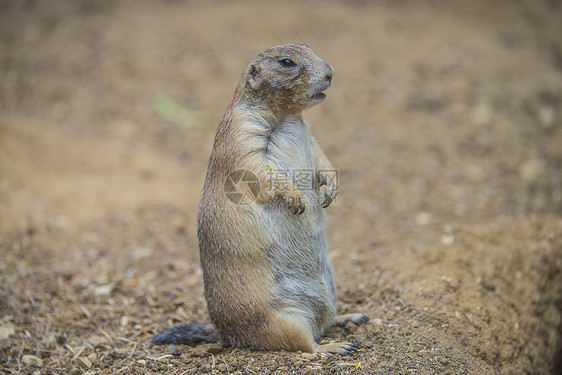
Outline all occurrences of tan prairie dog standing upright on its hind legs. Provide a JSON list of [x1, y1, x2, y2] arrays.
[[152, 44, 368, 354]]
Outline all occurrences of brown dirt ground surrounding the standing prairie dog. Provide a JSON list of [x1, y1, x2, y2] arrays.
[[0, 0, 562, 374]]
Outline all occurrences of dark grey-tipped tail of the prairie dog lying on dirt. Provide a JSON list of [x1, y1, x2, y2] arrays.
[[150, 323, 219, 345]]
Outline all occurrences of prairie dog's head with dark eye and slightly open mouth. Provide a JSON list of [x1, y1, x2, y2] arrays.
[[242, 44, 334, 111]]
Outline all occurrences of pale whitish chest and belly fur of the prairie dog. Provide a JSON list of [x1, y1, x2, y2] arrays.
[[256, 122, 336, 337]]
